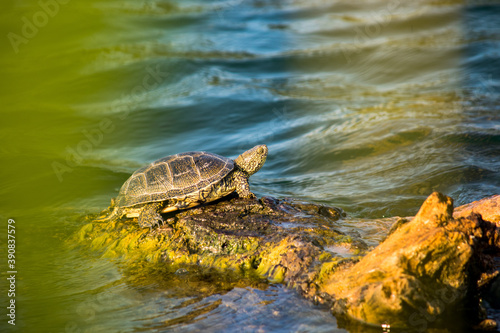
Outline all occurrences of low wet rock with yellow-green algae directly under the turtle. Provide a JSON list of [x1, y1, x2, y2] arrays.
[[75, 193, 356, 297]]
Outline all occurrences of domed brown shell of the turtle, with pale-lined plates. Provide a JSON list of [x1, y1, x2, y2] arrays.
[[116, 151, 234, 207]]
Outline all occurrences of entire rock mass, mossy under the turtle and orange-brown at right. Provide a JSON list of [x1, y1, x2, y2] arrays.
[[75, 193, 500, 330]]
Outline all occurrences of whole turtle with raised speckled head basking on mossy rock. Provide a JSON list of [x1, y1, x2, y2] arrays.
[[96, 145, 268, 229]]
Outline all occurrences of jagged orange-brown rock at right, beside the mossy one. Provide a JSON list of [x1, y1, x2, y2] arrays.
[[320, 192, 498, 330]]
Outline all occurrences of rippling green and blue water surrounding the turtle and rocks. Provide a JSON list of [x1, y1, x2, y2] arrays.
[[0, 0, 500, 332]]
